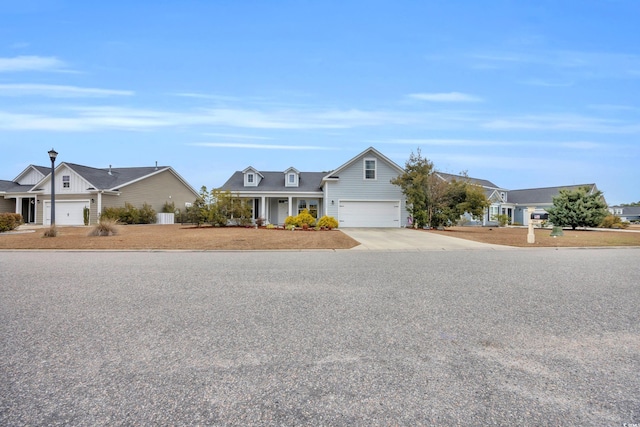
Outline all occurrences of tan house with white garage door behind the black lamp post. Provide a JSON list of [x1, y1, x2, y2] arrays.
[[0, 162, 198, 225]]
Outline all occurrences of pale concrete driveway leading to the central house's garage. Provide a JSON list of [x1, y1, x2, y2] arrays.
[[340, 228, 513, 252]]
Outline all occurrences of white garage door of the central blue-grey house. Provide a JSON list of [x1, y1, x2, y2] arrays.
[[338, 201, 400, 228]]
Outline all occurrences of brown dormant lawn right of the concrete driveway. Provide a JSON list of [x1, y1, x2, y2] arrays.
[[428, 227, 640, 248]]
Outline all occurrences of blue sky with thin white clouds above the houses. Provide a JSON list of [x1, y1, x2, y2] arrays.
[[0, 0, 640, 204]]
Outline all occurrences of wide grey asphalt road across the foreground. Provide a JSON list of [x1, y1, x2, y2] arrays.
[[0, 249, 640, 426]]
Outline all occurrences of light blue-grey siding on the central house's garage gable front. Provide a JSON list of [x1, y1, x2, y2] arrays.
[[325, 155, 408, 226]]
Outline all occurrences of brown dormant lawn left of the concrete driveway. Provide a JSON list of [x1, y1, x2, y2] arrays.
[[0, 224, 358, 250]]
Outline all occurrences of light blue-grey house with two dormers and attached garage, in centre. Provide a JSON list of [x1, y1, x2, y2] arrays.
[[220, 147, 408, 227]]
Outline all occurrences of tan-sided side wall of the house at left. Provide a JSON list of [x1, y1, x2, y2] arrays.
[[102, 170, 197, 216]]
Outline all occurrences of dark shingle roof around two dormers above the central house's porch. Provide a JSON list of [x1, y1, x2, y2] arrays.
[[220, 171, 326, 193]]
